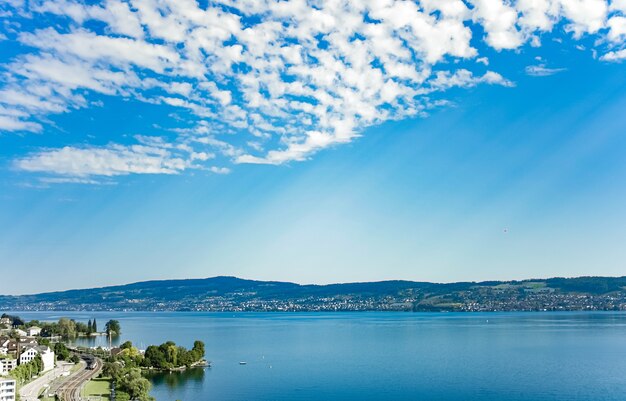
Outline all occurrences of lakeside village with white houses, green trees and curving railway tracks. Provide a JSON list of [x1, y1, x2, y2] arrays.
[[0, 314, 209, 401]]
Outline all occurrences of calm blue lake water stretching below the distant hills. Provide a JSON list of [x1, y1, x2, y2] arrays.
[[12, 312, 626, 401]]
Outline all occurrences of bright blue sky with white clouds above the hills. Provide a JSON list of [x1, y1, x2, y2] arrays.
[[0, 0, 626, 293]]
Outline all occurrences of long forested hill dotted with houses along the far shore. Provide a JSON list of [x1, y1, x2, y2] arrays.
[[0, 277, 626, 311]]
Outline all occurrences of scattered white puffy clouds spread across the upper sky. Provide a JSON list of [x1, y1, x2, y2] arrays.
[[0, 0, 626, 177]]
